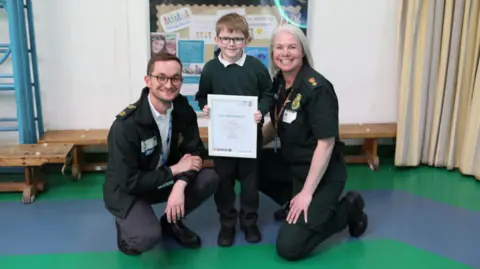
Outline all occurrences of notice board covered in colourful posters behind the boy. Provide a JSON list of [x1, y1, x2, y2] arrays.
[[149, 0, 308, 113]]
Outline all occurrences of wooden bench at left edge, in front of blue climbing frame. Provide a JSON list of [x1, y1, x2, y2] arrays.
[[0, 144, 73, 201]]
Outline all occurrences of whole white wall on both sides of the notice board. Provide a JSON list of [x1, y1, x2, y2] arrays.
[[0, 0, 397, 143]]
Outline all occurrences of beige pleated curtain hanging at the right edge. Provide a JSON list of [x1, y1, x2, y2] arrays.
[[395, 0, 480, 180]]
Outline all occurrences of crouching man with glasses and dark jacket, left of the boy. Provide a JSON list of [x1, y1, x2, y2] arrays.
[[103, 53, 219, 255]]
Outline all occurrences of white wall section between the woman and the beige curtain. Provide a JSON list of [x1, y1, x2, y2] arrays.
[[308, 0, 398, 123]]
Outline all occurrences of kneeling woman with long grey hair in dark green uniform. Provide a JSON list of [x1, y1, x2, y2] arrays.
[[259, 25, 368, 260]]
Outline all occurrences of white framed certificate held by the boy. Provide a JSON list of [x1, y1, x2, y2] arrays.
[[208, 94, 258, 158]]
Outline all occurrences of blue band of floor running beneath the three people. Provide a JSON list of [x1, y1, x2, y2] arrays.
[[0, 190, 480, 268]]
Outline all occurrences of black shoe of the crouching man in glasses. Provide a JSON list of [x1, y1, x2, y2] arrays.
[[160, 216, 202, 248]]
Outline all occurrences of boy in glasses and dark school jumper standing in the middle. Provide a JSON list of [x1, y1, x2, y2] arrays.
[[196, 13, 275, 246]]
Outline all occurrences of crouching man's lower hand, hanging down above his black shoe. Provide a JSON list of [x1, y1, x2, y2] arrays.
[[165, 180, 187, 223]]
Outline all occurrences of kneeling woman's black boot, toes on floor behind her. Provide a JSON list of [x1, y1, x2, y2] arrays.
[[344, 191, 368, 237]]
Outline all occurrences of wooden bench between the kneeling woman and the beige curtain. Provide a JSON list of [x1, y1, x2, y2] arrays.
[[340, 123, 397, 171]]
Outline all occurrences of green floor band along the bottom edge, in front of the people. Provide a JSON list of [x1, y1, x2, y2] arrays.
[[0, 240, 471, 269]]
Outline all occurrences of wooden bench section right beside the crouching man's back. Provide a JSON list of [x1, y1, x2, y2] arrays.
[[38, 129, 108, 179]]
